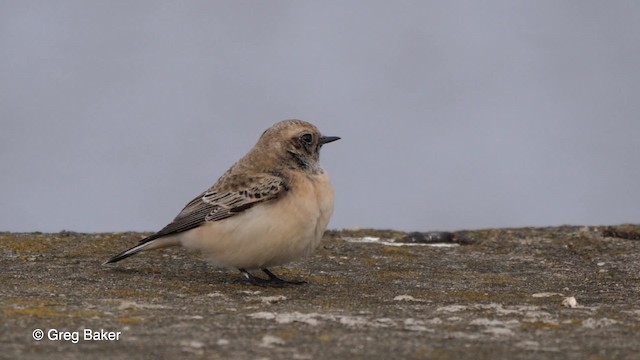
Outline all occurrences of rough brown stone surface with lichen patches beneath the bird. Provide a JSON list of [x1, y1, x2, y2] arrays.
[[0, 225, 640, 359]]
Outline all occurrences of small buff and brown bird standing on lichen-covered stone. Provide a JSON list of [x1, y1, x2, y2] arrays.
[[105, 120, 340, 286]]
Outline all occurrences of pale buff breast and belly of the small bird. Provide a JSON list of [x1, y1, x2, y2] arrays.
[[175, 173, 333, 269]]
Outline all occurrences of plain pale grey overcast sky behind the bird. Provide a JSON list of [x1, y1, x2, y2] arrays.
[[0, 0, 640, 232]]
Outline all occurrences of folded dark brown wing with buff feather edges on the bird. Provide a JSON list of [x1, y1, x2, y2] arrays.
[[140, 174, 288, 243]]
